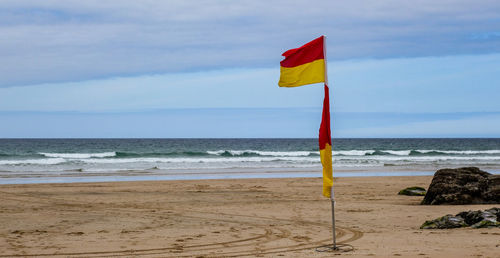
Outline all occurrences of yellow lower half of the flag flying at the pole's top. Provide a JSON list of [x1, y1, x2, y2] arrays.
[[278, 59, 325, 87]]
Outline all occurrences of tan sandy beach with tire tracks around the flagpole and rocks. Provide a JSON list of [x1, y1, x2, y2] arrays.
[[0, 176, 500, 257]]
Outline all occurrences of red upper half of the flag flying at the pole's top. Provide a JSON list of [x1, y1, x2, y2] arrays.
[[280, 36, 325, 67]]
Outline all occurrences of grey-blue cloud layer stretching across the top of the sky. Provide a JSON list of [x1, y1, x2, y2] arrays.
[[0, 0, 500, 87]]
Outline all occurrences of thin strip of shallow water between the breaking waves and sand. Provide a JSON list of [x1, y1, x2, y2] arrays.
[[0, 166, 500, 185]]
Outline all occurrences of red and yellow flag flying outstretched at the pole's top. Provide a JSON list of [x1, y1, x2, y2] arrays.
[[278, 36, 326, 87]]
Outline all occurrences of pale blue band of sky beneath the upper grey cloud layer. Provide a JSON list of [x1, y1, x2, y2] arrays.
[[0, 54, 500, 113]]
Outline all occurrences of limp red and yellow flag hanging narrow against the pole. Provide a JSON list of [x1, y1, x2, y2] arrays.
[[319, 84, 333, 198]]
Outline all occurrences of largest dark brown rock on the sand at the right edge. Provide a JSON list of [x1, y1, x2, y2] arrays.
[[422, 167, 500, 205]]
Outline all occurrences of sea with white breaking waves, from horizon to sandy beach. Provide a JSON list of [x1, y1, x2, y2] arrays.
[[0, 138, 500, 184]]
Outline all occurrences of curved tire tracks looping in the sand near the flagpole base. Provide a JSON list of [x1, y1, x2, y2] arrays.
[[0, 188, 363, 257]]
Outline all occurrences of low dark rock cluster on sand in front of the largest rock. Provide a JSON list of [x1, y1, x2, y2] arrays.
[[420, 208, 500, 229]]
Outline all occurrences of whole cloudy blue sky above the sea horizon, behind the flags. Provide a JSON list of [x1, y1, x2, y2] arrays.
[[0, 0, 500, 138]]
